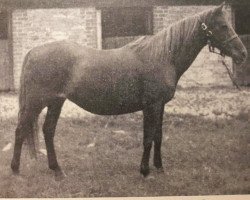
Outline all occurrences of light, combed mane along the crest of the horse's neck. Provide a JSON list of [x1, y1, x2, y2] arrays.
[[125, 9, 217, 62]]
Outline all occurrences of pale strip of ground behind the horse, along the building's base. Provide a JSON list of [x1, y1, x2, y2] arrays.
[[0, 87, 250, 119]]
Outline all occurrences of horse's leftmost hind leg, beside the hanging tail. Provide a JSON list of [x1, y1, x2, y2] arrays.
[[11, 107, 41, 173]]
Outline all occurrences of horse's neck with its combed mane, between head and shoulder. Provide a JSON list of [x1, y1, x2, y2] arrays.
[[126, 13, 205, 80]]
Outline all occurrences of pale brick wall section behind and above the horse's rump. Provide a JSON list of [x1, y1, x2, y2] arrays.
[[12, 7, 97, 89]]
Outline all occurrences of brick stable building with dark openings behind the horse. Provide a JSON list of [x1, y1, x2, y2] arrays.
[[0, 0, 250, 91]]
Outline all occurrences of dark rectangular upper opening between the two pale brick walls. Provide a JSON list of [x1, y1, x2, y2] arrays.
[[102, 8, 152, 38]]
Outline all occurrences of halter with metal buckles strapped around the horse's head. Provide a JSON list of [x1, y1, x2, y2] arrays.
[[201, 22, 238, 57]]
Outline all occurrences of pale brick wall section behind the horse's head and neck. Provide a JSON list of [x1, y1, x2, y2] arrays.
[[153, 6, 233, 88]]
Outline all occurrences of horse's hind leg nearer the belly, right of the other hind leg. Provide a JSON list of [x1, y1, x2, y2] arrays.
[[43, 99, 65, 180]]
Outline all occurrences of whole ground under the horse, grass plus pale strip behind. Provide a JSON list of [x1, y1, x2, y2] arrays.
[[0, 87, 250, 198]]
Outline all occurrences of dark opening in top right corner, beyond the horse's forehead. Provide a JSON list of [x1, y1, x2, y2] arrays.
[[235, 5, 250, 35]]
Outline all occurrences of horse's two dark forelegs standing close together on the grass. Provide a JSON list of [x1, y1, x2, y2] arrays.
[[140, 101, 164, 176]]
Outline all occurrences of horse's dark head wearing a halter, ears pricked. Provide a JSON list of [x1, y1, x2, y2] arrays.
[[204, 3, 247, 64]]
